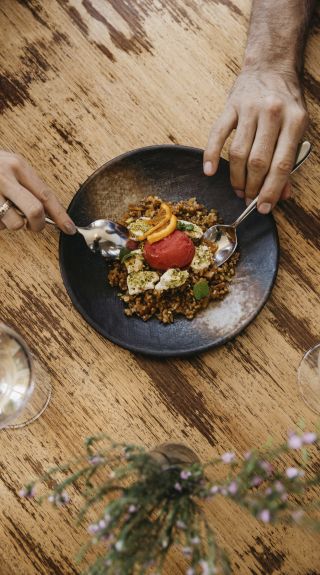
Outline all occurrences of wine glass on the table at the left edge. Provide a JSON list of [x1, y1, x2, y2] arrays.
[[0, 323, 51, 429]]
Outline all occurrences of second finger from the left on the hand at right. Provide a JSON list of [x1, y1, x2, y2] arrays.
[[229, 110, 257, 198]]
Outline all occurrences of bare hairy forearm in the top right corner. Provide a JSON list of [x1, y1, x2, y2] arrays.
[[244, 0, 315, 77]]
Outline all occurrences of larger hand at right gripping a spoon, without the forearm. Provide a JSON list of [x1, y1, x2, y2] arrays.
[[204, 69, 308, 214]]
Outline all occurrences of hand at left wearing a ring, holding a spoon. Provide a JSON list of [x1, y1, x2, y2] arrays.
[[0, 150, 76, 234]]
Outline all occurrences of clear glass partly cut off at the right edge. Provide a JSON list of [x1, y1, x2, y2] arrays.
[[298, 343, 320, 413]]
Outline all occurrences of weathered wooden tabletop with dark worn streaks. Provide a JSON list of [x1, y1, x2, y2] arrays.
[[0, 0, 320, 575]]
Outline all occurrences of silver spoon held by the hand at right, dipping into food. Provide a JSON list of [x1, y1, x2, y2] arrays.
[[204, 141, 311, 266]]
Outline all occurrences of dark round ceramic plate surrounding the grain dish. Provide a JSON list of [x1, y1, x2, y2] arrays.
[[60, 145, 279, 356]]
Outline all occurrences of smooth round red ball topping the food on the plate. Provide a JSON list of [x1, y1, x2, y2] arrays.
[[144, 230, 195, 270]]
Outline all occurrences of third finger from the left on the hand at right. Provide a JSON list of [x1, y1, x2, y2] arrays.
[[245, 98, 282, 203]]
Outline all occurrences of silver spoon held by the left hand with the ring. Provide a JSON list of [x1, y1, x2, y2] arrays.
[[45, 217, 138, 259]]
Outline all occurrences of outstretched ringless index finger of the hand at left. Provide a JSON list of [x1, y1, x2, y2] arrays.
[[17, 162, 77, 234]]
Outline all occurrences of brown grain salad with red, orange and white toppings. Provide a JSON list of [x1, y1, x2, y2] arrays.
[[107, 196, 239, 323]]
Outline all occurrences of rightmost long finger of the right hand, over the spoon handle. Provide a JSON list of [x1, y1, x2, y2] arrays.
[[258, 116, 303, 214]]
